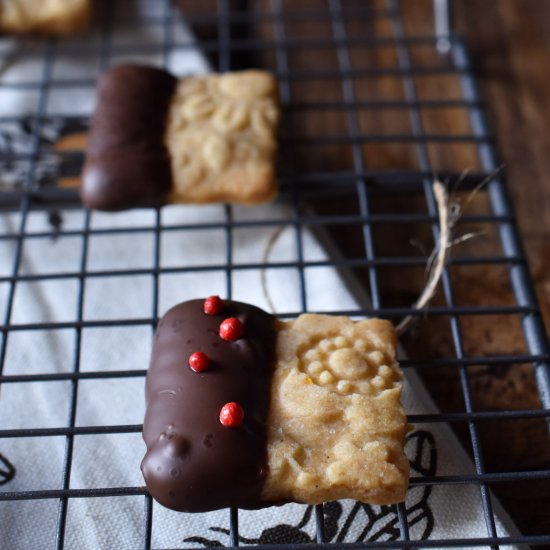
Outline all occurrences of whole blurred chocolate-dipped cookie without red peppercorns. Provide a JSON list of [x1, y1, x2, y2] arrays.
[[81, 65, 279, 211]]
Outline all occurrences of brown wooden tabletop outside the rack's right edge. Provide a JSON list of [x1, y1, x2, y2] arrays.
[[456, 0, 550, 340]]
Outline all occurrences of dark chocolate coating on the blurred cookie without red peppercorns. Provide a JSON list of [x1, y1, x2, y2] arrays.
[[80, 65, 177, 211]]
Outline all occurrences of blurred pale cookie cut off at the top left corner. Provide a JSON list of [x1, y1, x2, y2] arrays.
[[0, 0, 91, 35]]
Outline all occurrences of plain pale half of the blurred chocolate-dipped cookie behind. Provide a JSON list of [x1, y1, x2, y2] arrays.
[[166, 70, 279, 204]]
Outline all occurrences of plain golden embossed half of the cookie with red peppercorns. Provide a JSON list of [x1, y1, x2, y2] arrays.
[[262, 315, 409, 504]]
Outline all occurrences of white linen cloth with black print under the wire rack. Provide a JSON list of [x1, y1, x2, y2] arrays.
[[0, 3, 515, 550]]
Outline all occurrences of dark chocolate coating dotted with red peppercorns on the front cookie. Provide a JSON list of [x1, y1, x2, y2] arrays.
[[141, 300, 275, 512]]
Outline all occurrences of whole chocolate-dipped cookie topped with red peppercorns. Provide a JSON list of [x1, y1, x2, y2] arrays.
[[141, 297, 408, 512]]
